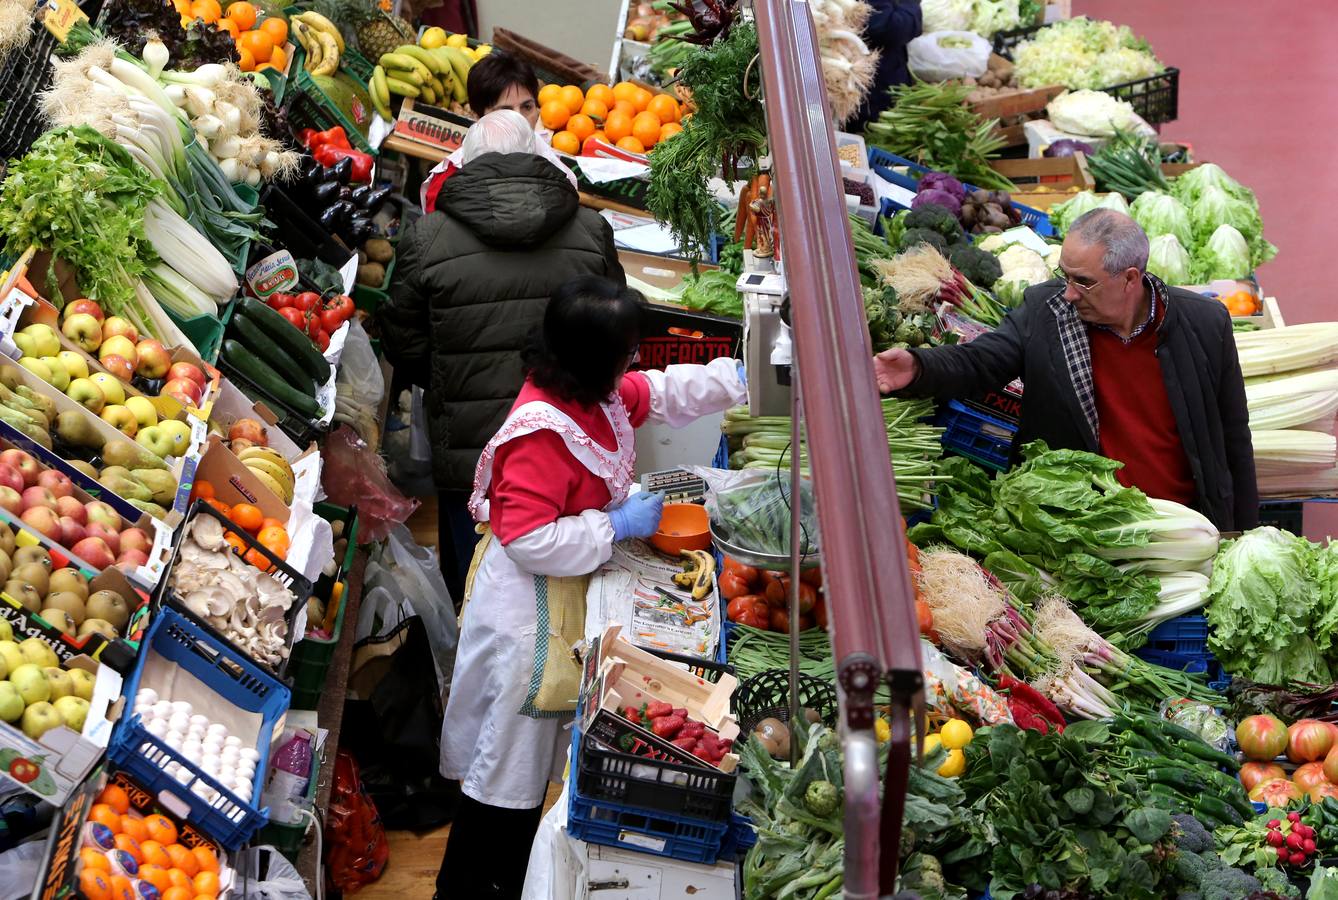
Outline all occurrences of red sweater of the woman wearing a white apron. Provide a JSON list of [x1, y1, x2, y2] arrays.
[[488, 372, 650, 547]]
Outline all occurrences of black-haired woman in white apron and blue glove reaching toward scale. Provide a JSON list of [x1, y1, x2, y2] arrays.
[[438, 275, 748, 900]]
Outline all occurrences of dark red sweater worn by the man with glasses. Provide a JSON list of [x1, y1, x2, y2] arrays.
[[1088, 309, 1195, 505]]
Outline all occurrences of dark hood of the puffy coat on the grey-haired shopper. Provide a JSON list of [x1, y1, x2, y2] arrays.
[[438, 154, 579, 246]]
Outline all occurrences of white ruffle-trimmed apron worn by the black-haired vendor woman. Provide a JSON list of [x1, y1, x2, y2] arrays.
[[442, 395, 636, 809]]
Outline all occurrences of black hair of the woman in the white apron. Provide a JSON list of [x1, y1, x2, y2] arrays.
[[523, 275, 646, 407]]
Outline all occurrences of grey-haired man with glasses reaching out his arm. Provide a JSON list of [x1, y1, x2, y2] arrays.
[[874, 209, 1259, 531]]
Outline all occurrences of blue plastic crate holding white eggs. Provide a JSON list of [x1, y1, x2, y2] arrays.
[[107, 607, 290, 851]]
